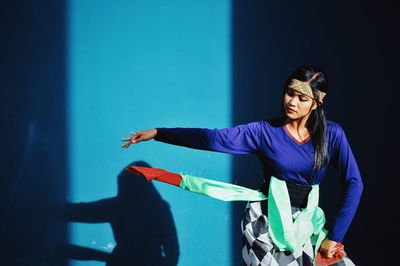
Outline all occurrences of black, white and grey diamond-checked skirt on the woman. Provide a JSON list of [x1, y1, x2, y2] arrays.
[[241, 200, 354, 266]]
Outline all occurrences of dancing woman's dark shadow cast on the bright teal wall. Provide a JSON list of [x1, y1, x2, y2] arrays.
[[62, 161, 179, 266]]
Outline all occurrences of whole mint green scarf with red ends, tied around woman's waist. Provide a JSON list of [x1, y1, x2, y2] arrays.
[[125, 166, 346, 265]]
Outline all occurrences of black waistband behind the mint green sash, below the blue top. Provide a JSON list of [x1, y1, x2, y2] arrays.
[[261, 182, 312, 208]]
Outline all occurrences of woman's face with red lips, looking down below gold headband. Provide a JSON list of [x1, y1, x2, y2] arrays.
[[283, 88, 317, 120]]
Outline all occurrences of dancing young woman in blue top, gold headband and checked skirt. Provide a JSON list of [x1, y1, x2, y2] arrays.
[[122, 66, 363, 265]]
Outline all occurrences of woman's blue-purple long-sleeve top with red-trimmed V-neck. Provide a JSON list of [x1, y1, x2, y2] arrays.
[[155, 119, 363, 242]]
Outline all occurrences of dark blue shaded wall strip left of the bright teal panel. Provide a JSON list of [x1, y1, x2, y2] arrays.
[[0, 0, 68, 266]]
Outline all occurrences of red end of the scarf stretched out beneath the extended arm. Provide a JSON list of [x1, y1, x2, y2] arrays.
[[125, 166, 182, 187]]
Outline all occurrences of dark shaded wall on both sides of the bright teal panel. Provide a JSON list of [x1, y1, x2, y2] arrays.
[[0, 0, 399, 265]]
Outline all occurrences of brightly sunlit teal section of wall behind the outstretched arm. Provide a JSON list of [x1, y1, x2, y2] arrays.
[[67, 0, 233, 266]]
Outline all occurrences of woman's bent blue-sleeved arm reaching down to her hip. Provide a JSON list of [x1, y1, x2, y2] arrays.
[[328, 126, 363, 242]]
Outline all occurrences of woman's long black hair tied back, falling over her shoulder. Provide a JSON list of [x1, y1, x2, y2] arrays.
[[284, 66, 328, 170]]
